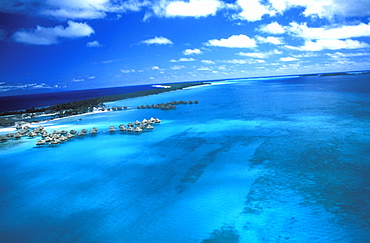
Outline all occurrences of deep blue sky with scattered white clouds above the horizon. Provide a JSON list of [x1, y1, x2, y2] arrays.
[[0, 0, 370, 95]]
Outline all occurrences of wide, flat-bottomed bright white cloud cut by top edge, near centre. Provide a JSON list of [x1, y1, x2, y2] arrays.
[[165, 0, 222, 18]]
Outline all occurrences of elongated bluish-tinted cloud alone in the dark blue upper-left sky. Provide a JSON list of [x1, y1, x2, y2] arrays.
[[13, 21, 94, 45]]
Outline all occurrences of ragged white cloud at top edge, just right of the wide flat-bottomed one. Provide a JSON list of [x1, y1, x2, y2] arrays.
[[233, 0, 276, 22]]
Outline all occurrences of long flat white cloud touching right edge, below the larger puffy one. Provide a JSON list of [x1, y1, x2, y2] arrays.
[[286, 39, 370, 51]]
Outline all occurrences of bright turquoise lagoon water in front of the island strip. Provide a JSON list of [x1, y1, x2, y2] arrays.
[[0, 74, 370, 243]]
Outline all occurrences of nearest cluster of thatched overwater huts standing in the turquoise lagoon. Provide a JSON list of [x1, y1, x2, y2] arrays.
[[0, 117, 161, 146]]
